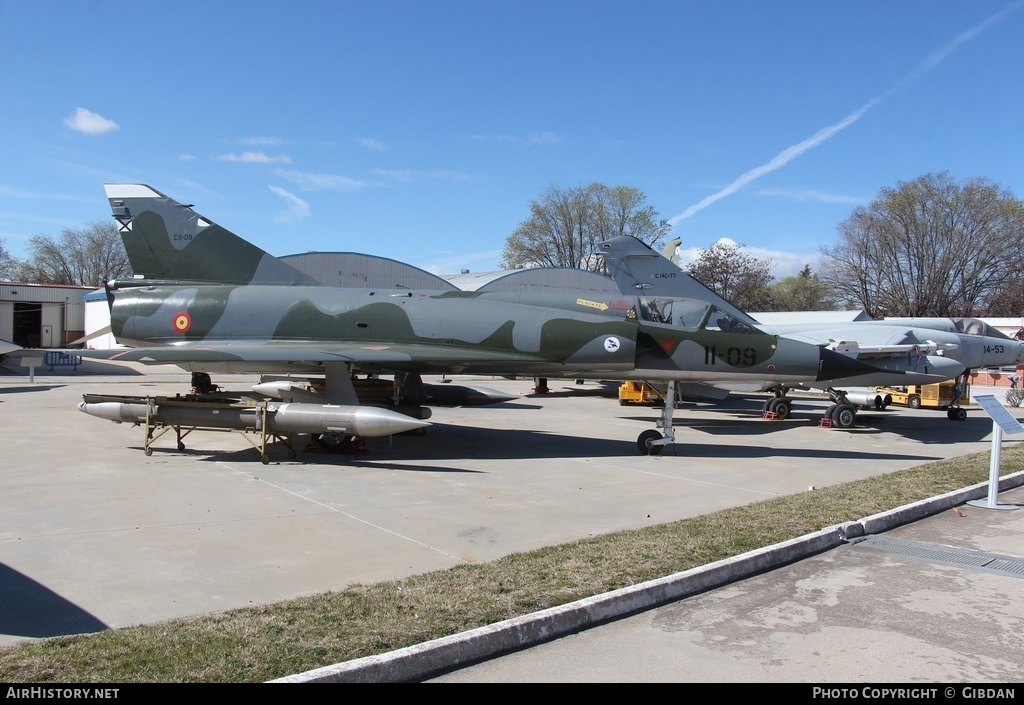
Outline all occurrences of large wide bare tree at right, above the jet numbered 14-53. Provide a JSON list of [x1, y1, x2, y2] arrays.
[[822, 172, 1024, 317]]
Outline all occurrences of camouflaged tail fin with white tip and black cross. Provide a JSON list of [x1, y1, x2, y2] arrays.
[[103, 183, 317, 285]]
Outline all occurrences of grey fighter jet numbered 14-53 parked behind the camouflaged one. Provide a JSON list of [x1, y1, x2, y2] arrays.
[[601, 237, 1024, 428]]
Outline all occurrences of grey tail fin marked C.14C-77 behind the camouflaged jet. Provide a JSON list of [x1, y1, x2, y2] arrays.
[[601, 235, 761, 326]]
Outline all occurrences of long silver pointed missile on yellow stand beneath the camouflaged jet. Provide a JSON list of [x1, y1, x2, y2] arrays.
[[78, 402, 430, 438]]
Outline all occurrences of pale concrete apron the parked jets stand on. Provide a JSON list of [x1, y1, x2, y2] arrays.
[[0, 362, 1017, 684]]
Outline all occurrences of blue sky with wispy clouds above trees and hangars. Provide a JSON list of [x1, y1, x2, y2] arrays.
[[0, 0, 1024, 277]]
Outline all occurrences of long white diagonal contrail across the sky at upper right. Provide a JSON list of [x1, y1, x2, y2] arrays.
[[669, 0, 1024, 227]]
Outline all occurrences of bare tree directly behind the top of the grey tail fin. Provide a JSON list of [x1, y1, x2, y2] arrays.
[[502, 183, 670, 271]]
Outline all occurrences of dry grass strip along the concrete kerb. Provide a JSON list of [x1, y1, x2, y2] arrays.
[[0, 445, 1024, 682]]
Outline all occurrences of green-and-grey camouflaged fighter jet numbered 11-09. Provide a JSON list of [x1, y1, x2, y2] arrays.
[[80, 183, 873, 461]]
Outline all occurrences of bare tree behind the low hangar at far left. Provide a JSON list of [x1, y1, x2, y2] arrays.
[[22, 220, 131, 286]]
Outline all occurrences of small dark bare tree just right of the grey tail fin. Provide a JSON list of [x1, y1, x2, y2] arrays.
[[690, 242, 772, 310]]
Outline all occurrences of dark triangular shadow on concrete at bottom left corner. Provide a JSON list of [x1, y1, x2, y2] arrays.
[[0, 564, 108, 638]]
